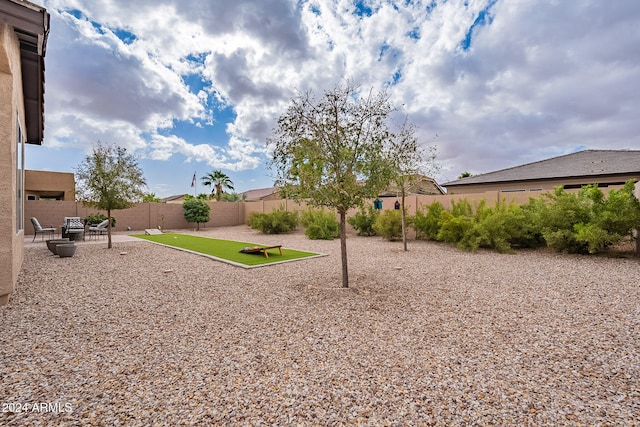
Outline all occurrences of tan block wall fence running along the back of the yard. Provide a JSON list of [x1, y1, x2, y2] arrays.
[[24, 187, 619, 235]]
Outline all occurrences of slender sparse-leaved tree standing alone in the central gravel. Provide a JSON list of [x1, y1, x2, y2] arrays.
[[267, 83, 393, 288]]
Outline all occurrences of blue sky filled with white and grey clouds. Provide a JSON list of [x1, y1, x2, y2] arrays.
[[25, 0, 640, 197]]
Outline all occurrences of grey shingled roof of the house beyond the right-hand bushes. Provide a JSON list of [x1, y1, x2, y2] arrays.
[[442, 150, 640, 187]]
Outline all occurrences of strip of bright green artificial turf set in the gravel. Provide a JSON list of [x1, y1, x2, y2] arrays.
[[133, 233, 320, 266]]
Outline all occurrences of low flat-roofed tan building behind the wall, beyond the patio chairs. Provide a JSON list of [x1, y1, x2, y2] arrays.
[[24, 170, 76, 201]]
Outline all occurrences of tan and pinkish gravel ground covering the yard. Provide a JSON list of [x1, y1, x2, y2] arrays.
[[0, 226, 640, 426]]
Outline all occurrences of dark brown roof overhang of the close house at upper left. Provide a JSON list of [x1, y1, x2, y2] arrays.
[[0, 0, 50, 145]]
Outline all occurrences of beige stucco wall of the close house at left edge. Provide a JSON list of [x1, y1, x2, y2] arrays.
[[0, 23, 26, 305]]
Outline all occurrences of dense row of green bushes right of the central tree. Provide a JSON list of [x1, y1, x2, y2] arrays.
[[350, 181, 640, 254]]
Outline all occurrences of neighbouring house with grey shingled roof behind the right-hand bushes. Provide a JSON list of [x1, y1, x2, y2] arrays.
[[442, 150, 640, 194]]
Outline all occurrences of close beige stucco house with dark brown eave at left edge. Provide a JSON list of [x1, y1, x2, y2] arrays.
[[0, 0, 50, 305]]
